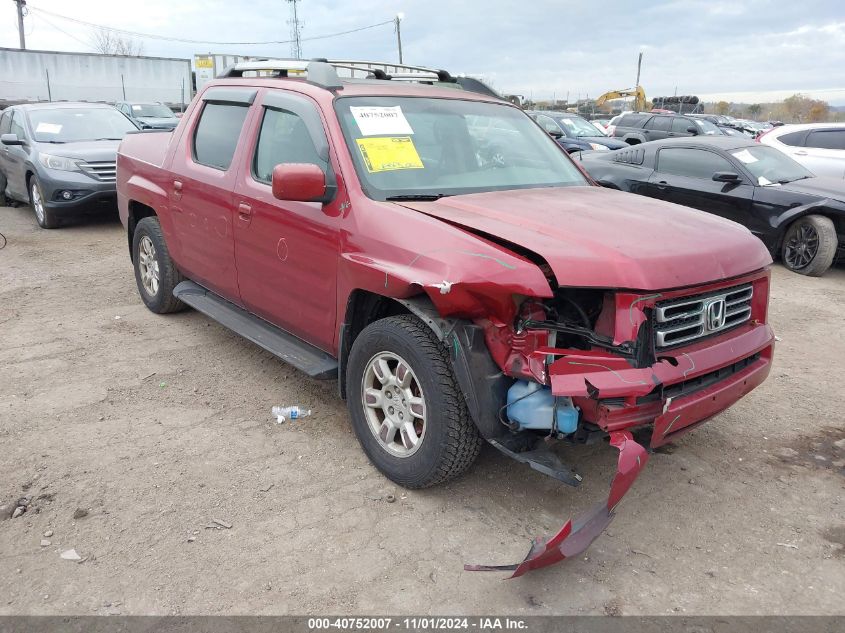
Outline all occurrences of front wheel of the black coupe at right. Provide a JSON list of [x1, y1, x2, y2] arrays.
[[781, 215, 839, 277]]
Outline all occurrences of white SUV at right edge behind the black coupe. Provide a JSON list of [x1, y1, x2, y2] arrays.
[[760, 123, 845, 178]]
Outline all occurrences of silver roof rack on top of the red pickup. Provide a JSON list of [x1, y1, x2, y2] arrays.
[[217, 58, 457, 89]]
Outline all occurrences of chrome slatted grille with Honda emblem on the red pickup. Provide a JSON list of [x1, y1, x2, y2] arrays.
[[654, 284, 754, 349]]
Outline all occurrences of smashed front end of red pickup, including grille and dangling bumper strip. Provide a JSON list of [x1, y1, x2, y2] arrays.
[[444, 270, 774, 577]]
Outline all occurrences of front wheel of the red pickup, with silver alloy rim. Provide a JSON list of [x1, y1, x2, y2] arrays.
[[346, 315, 482, 488]]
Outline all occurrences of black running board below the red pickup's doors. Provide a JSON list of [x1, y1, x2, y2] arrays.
[[173, 281, 338, 380]]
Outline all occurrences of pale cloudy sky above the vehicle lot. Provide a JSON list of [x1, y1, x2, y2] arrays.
[[0, 0, 845, 105]]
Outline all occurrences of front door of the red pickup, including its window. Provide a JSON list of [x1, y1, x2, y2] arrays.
[[234, 91, 343, 351]]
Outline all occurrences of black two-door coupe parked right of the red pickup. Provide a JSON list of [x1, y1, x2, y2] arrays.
[[580, 136, 845, 276]]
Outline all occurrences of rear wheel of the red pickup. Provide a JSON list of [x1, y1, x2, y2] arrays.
[[132, 217, 186, 314]]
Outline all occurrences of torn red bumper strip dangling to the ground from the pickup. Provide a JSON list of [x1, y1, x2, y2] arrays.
[[464, 431, 648, 578]]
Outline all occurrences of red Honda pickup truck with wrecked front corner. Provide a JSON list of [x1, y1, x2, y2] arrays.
[[117, 61, 774, 576]]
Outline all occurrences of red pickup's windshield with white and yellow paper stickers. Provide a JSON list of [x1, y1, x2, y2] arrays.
[[335, 97, 587, 200]]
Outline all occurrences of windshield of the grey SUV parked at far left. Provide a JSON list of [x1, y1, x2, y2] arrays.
[[28, 107, 138, 143]]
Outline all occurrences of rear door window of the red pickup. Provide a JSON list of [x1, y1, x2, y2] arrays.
[[194, 102, 249, 171]]
